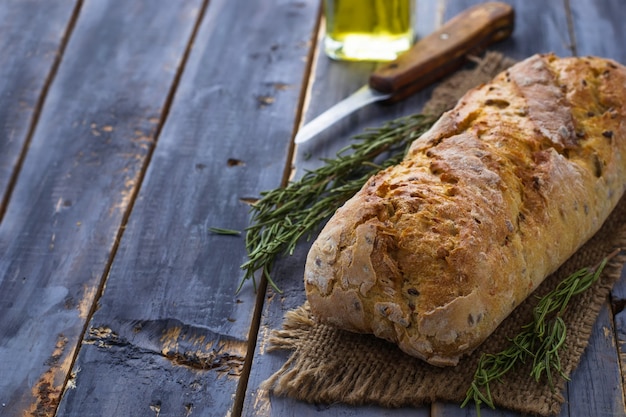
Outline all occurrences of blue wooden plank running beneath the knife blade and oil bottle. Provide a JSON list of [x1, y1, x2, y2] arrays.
[[243, 1, 440, 417]]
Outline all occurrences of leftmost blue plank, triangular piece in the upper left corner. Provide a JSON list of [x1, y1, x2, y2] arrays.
[[0, 0, 78, 216]]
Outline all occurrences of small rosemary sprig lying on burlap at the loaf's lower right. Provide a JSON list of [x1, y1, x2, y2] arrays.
[[461, 250, 619, 417]]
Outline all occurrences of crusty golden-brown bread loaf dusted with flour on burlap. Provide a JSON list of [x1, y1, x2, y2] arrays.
[[305, 55, 626, 366]]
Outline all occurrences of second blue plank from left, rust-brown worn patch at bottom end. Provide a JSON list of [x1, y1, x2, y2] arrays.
[[0, 0, 200, 416]]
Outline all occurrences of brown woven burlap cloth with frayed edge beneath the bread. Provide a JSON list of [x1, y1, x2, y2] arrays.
[[263, 53, 626, 415]]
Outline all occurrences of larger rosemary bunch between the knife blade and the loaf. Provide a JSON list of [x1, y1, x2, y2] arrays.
[[239, 114, 436, 292]]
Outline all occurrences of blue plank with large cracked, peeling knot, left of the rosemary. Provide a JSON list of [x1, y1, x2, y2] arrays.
[[54, 0, 319, 416]]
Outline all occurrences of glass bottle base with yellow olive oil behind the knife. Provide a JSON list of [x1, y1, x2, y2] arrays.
[[324, 0, 414, 61]]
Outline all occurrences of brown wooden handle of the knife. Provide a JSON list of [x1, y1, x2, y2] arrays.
[[369, 2, 515, 102]]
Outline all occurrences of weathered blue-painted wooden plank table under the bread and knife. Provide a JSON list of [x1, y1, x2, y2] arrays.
[[0, 0, 626, 417]]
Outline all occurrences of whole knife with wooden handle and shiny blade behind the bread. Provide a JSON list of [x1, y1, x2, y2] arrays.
[[295, 2, 515, 143]]
